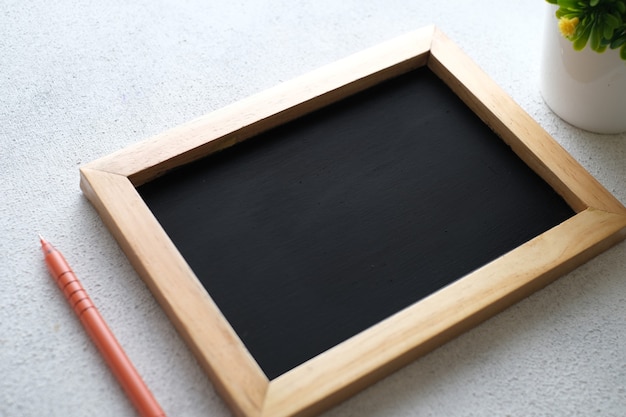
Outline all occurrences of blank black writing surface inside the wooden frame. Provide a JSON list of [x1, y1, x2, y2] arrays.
[[138, 68, 575, 379]]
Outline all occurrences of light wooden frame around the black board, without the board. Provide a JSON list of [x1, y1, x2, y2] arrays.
[[81, 27, 626, 417]]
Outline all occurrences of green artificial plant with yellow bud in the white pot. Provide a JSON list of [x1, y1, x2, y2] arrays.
[[546, 0, 626, 61]]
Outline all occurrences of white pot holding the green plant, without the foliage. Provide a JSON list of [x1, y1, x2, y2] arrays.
[[541, 4, 626, 133]]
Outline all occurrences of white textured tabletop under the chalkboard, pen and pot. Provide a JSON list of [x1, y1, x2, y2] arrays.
[[0, 0, 626, 417]]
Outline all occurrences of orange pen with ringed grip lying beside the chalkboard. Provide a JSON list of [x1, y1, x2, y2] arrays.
[[39, 236, 165, 417]]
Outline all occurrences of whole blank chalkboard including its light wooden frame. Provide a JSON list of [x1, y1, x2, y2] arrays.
[[80, 26, 626, 417]]
